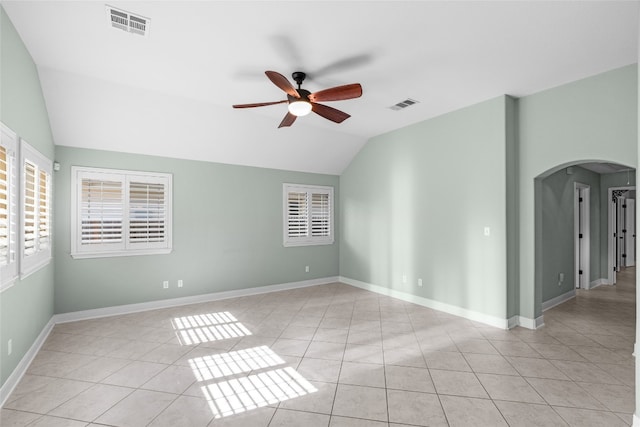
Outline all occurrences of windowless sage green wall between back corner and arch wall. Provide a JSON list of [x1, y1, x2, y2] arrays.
[[340, 96, 510, 319]]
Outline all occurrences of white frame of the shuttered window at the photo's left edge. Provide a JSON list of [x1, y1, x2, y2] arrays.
[[0, 123, 20, 292]]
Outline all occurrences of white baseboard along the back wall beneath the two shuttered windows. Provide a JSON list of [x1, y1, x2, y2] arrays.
[[53, 276, 338, 323]]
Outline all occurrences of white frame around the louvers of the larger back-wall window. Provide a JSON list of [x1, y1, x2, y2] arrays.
[[71, 166, 173, 259]]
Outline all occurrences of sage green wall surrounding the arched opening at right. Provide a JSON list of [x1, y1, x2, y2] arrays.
[[518, 64, 638, 319]]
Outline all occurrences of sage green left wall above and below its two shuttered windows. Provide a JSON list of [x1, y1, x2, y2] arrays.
[[0, 6, 55, 385]]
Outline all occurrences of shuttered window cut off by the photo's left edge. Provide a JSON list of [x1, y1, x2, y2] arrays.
[[0, 124, 18, 290]]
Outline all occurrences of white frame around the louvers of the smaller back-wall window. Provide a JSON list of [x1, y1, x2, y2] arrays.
[[282, 183, 335, 247]]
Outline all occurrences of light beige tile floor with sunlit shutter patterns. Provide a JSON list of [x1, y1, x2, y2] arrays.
[[0, 269, 635, 427]]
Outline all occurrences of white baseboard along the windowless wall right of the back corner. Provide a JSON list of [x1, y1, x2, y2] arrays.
[[339, 276, 515, 329]]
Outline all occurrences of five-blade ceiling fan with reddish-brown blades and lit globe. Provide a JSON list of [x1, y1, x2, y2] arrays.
[[233, 71, 362, 128]]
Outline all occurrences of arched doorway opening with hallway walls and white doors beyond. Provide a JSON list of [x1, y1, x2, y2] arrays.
[[535, 161, 636, 320]]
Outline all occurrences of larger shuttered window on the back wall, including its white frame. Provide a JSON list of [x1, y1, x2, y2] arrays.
[[71, 166, 172, 258]]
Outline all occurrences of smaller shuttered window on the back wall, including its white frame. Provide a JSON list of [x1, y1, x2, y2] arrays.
[[283, 184, 333, 246]]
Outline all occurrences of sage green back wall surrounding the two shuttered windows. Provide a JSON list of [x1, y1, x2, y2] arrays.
[[55, 146, 340, 313]]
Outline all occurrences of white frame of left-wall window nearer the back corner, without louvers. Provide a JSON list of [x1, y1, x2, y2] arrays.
[[19, 138, 53, 279]]
